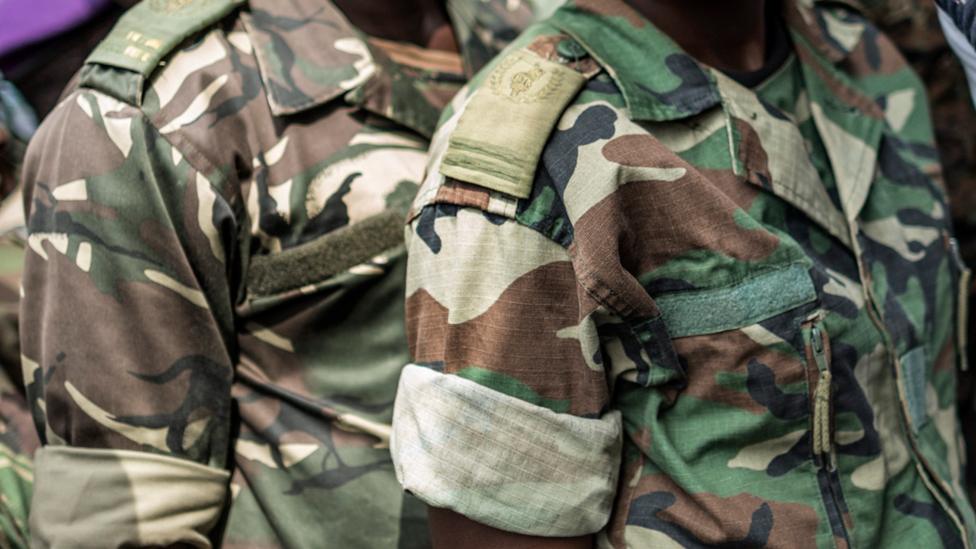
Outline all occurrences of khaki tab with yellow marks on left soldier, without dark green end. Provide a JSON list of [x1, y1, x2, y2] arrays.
[[85, 0, 246, 78]]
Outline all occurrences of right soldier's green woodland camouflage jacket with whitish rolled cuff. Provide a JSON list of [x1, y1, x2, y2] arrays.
[[391, 0, 976, 549]]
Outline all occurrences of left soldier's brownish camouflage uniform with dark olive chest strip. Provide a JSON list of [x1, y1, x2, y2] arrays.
[[21, 0, 530, 548]]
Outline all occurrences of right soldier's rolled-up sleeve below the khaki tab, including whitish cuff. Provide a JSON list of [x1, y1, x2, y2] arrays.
[[392, 204, 621, 537]]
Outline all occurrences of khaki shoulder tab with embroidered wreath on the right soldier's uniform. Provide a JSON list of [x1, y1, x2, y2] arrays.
[[440, 37, 599, 198]]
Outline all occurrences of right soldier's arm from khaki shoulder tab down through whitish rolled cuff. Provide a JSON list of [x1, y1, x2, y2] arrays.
[[391, 35, 624, 547]]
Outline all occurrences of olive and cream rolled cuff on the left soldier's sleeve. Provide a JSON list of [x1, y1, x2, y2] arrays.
[[30, 446, 230, 547]]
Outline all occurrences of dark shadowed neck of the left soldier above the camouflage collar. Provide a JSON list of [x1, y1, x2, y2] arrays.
[[332, 0, 458, 51]]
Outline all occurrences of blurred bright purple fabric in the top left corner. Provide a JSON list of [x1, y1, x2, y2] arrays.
[[0, 0, 110, 57]]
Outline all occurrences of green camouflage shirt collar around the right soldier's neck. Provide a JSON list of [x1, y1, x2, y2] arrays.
[[549, 0, 849, 121]]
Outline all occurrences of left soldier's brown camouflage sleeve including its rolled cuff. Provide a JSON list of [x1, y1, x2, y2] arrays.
[[21, 90, 236, 547]]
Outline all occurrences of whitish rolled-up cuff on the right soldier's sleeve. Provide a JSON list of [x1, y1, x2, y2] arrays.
[[390, 365, 621, 537]]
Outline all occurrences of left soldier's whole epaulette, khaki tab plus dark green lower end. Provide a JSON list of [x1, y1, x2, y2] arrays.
[[81, 0, 247, 105]]
